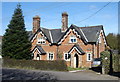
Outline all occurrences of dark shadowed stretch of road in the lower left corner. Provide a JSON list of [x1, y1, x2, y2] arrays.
[[2, 68, 56, 80]]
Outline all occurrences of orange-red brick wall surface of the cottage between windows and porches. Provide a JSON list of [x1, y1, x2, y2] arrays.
[[32, 31, 105, 67]]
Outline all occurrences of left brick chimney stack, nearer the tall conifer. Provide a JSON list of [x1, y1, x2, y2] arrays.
[[32, 15, 40, 34]]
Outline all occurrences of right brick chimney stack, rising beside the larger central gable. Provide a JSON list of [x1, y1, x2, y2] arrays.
[[61, 12, 68, 32]]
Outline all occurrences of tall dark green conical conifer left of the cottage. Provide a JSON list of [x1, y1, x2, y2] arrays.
[[2, 4, 31, 59]]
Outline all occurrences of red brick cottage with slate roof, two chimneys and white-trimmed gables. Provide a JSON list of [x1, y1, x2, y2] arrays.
[[29, 12, 107, 68]]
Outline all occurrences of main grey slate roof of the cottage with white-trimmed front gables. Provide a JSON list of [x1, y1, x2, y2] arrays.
[[29, 24, 103, 44]]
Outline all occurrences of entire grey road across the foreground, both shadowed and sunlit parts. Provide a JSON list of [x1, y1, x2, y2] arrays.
[[3, 69, 118, 80]]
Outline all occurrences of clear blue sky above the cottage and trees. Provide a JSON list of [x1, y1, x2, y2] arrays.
[[0, 2, 118, 35]]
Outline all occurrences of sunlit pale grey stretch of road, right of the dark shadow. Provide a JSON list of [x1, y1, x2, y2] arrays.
[[44, 70, 118, 80]]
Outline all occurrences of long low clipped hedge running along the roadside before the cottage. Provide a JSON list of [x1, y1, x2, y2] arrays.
[[3, 58, 68, 71]]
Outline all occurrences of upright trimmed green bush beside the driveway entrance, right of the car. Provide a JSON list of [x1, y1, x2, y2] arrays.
[[101, 51, 110, 74]]
